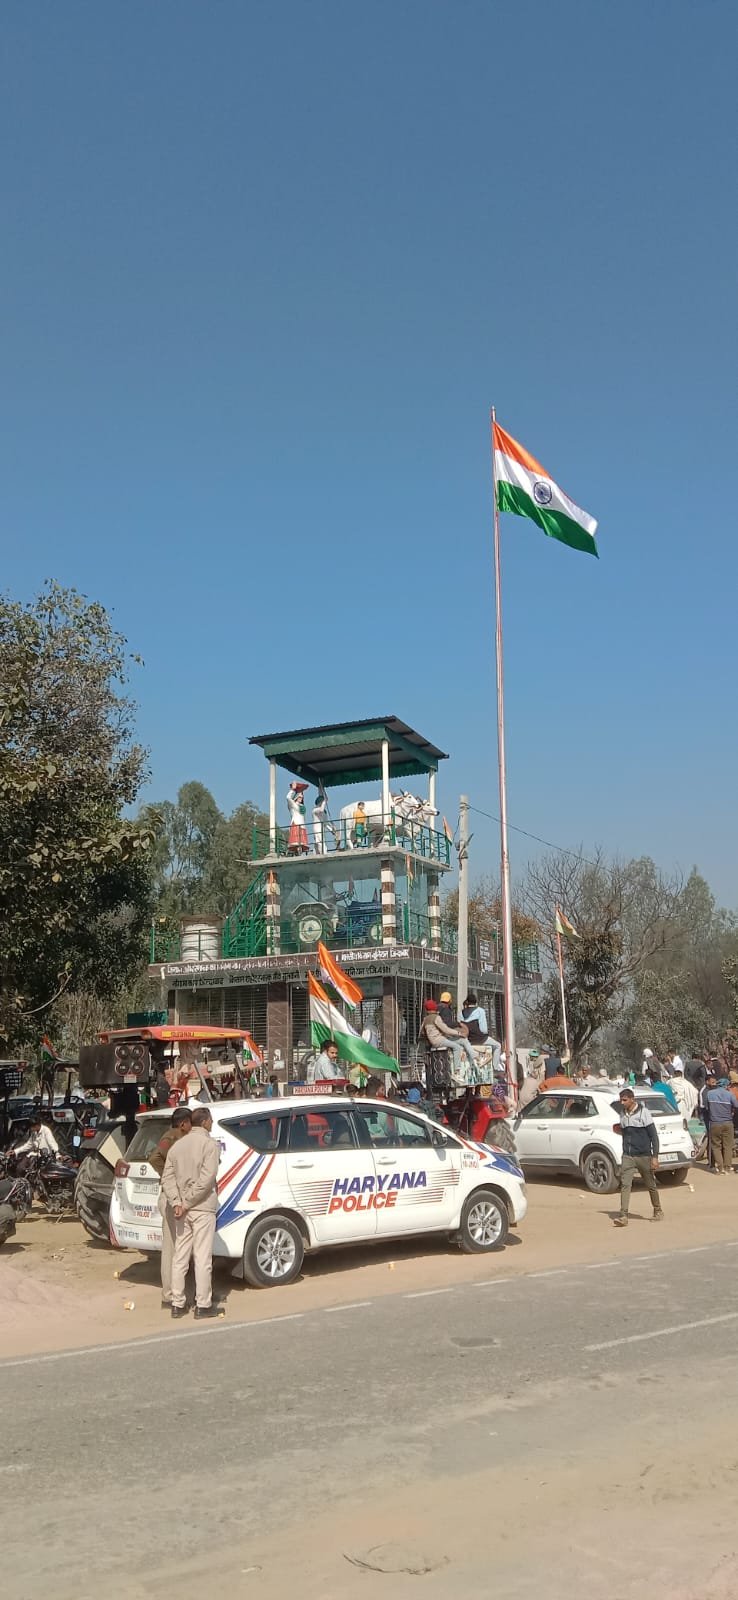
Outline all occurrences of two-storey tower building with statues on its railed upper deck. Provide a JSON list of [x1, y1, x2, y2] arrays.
[[150, 717, 518, 1077]]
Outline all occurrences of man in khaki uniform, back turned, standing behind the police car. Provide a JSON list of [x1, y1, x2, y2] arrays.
[[162, 1106, 223, 1317]]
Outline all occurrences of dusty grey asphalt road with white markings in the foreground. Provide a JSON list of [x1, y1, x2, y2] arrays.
[[0, 1240, 738, 1600]]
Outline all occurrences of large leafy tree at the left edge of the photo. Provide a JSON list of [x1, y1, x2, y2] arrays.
[[0, 584, 155, 1053]]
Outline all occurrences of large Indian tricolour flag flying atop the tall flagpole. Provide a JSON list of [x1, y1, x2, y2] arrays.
[[491, 422, 597, 555]]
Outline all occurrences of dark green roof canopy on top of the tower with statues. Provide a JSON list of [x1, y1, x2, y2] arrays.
[[248, 717, 448, 789]]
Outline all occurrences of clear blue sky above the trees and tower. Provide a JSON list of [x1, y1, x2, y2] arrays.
[[0, 0, 738, 904]]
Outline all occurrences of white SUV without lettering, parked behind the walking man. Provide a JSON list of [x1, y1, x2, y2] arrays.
[[514, 1085, 696, 1194]]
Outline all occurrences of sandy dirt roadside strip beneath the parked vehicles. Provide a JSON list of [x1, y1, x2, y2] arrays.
[[0, 1168, 738, 1357]]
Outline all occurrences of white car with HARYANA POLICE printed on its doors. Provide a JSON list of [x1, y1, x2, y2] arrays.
[[110, 1094, 527, 1286]]
